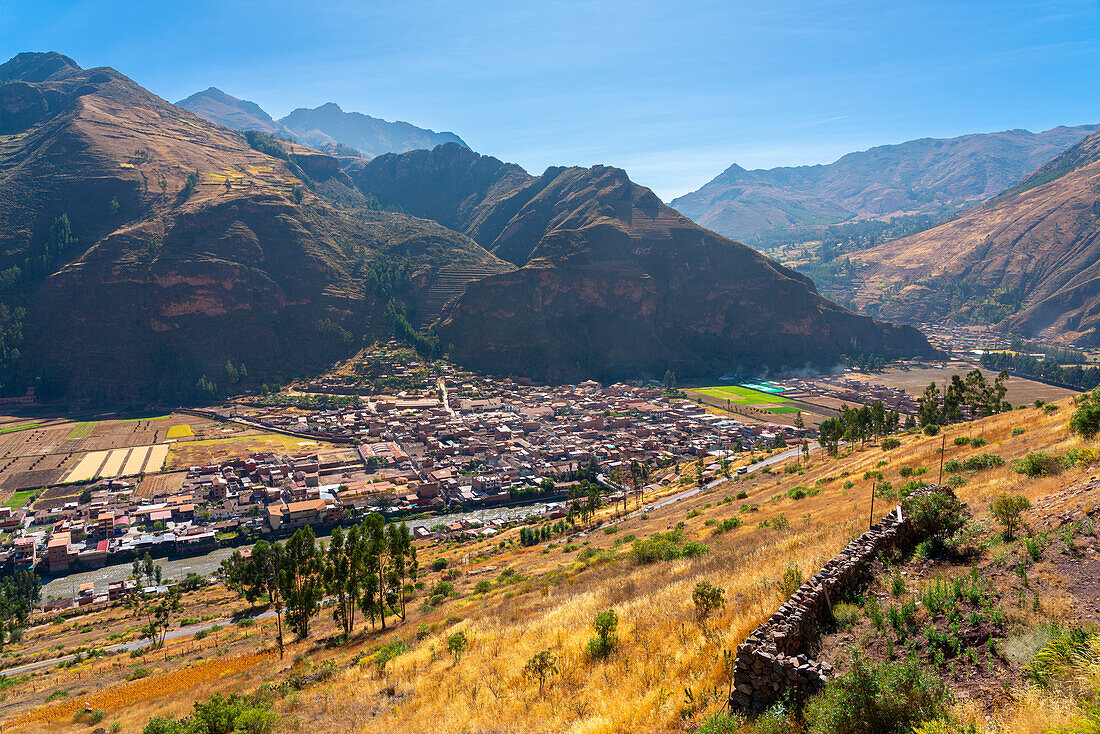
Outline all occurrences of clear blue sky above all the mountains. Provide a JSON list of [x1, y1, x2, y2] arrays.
[[0, 0, 1100, 200]]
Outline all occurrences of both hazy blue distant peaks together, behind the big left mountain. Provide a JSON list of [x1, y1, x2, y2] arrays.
[[176, 87, 465, 157]]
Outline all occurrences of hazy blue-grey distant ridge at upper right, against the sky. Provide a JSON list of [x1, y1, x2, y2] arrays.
[[672, 125, 1097, 238]]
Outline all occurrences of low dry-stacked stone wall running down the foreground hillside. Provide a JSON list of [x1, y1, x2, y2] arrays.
[[729, 485, 950, 712]]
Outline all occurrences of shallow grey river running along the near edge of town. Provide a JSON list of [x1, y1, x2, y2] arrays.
[[42, 502, 547, 600]]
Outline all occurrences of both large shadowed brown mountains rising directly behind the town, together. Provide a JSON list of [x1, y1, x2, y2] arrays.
[[0, 53, 933, 402]]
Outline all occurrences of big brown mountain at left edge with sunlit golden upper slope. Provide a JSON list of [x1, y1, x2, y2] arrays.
[[0, 54, 510, 401]]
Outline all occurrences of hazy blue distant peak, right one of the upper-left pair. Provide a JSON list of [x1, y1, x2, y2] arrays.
[[279, 102, 468, 158]]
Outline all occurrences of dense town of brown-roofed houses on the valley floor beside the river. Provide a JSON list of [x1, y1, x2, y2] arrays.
[[0, 368, 807, 576]]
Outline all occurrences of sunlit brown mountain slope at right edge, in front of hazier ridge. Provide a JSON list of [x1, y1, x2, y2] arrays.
[[854, 126, 1100, 346]]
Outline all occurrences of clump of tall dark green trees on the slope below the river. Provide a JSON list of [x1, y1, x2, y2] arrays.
[[222, 513, 419, 655]]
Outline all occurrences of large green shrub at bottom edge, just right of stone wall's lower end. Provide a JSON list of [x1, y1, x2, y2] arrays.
[[805, 651, 950, 734]]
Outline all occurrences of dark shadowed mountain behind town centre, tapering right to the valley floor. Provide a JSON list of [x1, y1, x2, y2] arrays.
[[350, 145, 931, 380]]
